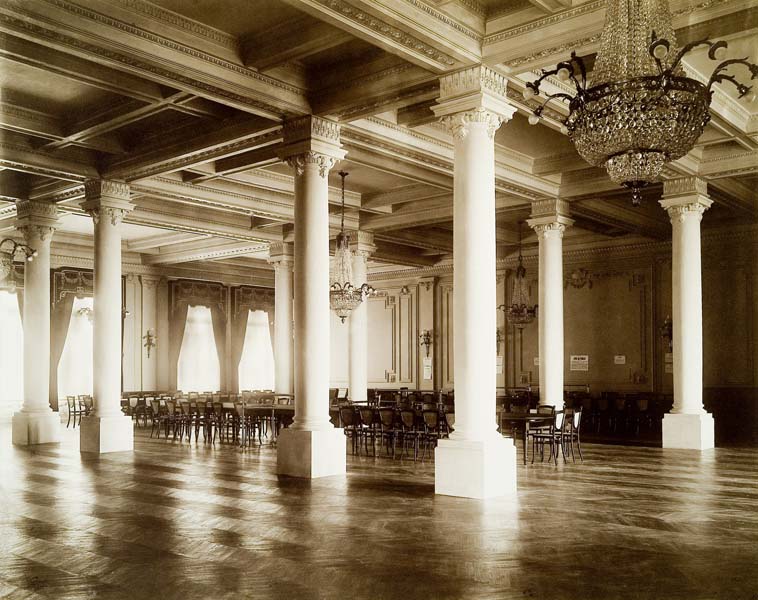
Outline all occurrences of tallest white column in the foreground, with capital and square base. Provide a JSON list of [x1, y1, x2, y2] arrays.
[[433, 66, 516, 498]]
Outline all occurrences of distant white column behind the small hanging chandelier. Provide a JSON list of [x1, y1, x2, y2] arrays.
[[348, 231, 376, 402]]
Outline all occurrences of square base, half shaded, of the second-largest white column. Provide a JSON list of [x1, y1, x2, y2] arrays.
[[276, 427, 347, 479]]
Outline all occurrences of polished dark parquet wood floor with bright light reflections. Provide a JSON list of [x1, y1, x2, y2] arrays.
[[0, 425, 758, 600]]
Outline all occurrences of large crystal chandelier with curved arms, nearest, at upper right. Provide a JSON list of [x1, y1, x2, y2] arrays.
[[524, 0, 758, 206]]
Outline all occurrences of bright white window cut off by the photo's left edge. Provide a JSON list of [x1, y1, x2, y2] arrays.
[[0, 291, 24, 418]]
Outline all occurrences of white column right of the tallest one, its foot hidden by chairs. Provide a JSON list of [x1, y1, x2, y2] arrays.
[[528, 199, 574, 410]]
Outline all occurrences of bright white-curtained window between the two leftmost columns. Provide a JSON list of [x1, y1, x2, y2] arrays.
[[58, 298, 94, 398]]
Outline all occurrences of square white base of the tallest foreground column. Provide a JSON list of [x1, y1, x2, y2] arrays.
[[434, 436, 517, 499]]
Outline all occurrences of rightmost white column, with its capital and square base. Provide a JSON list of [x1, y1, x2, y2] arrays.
[[660, 177, 714, 450]]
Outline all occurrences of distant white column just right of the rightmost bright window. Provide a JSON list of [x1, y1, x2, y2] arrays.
[[269, 242, 295, 394]]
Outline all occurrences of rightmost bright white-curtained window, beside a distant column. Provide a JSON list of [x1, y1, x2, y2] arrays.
[[239, 310, 274, 390]]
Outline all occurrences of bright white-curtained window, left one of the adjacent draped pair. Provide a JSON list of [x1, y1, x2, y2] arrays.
[[177, 306, 221, 392]]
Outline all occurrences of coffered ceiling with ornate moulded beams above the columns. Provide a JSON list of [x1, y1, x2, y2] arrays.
[[0, 0, 758, 270]]
